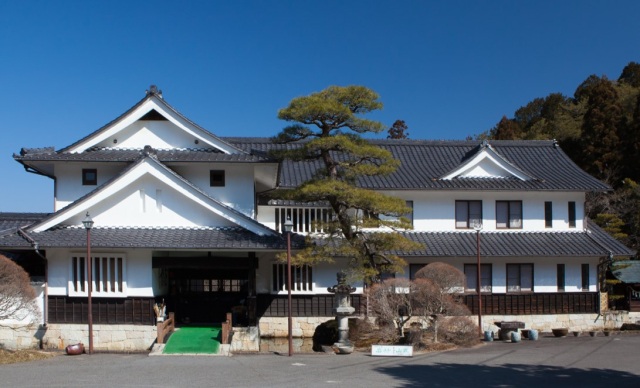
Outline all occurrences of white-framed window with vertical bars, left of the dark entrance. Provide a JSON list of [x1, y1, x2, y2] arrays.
[[69, 255, 126, 297]]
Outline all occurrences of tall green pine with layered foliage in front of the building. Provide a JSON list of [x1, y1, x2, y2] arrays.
[[273, 86, 421, 283]]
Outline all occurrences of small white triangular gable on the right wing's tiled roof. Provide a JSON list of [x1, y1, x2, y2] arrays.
[[440, 140, 535, 181]]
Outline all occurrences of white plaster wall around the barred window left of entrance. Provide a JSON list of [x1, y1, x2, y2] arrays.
[[47, 249, 154, 298]]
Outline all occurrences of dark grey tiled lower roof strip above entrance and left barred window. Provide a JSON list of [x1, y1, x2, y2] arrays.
[[0, 227, 304, 250]]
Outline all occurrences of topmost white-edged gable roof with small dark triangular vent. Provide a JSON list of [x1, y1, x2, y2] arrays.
[[58, 85, 244, 154]]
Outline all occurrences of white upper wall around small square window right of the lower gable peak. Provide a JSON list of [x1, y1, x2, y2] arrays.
[[171, 163, 255, 217]]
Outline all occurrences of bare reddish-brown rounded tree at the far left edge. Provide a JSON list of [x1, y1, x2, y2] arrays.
[[0, 255, 39, 324]]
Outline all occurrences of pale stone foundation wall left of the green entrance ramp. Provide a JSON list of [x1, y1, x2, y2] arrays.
[[0, 324, 157, 352]]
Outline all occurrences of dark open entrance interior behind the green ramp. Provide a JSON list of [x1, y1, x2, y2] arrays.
[[153, 257, 255, 325]]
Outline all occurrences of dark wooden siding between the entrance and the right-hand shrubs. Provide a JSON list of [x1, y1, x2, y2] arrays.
[[256, 294, 364, 318]]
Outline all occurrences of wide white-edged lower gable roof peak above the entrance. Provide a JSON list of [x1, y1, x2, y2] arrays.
[[27, 148, 277, 235]]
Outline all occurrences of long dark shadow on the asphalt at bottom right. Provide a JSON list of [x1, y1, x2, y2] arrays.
[[377, 364, 640, 388]]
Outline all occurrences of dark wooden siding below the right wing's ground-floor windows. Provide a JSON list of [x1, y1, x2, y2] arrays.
[[464, 292, 599, 315]]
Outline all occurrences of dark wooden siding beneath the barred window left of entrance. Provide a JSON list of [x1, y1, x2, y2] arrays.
[[49, 296, 155, 325]]
